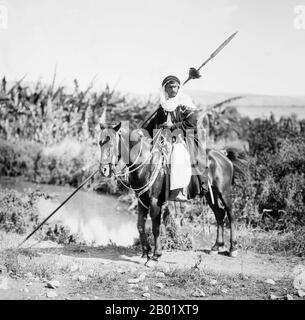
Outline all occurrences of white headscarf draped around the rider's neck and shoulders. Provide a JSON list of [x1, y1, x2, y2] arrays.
[[160, 86, 196, 112]]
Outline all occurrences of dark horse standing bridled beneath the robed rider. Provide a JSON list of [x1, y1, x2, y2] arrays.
[[99, 117, 243, 260]]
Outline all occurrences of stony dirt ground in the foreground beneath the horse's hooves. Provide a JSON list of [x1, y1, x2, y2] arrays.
[[0, 246, 304, 300]]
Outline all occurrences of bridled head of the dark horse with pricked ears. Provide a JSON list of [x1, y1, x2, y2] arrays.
[[99, 108, 121, 177]]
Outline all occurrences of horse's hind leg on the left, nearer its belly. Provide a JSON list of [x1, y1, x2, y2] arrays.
[[206, 188, 225, 254]]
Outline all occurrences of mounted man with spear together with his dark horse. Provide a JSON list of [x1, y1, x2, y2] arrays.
[[99, 33, 244, 262]]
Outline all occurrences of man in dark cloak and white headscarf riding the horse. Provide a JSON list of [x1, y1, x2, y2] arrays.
[[143, 75, 202, 201]]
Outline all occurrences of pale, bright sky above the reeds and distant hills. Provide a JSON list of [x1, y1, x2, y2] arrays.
[[0, 0, 305, 95]]
